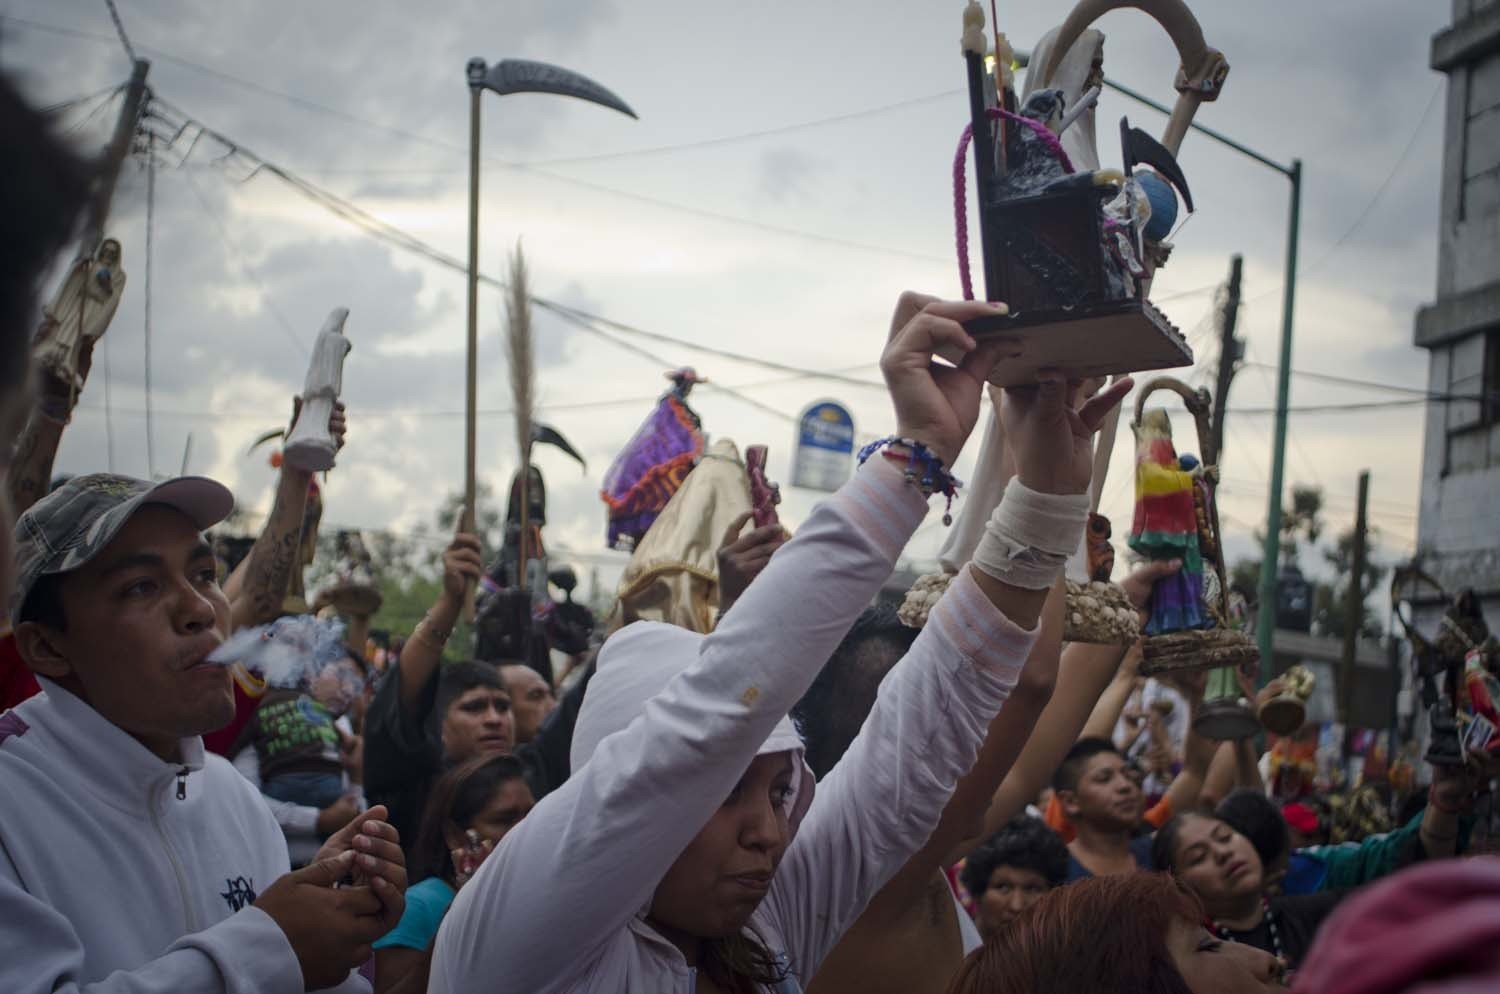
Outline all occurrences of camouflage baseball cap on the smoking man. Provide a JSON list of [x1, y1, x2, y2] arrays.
[[8, 472, 234, 624]]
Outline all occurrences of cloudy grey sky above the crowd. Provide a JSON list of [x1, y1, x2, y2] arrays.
[[0, 0, 1448, 599]]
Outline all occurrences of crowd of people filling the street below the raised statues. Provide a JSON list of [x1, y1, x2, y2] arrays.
[[0, 65, 1500, 994]]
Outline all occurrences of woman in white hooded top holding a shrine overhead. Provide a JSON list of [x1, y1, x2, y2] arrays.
[[431, 294, 1130, 994]]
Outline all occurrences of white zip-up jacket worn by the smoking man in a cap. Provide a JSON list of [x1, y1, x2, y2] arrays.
[[0, 679, 369, 994]]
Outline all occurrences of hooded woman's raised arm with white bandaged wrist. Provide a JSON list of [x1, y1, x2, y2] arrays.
[[765, 368, 1130, 979]]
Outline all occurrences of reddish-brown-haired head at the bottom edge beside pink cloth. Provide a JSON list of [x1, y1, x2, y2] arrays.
[[948, 873, 1283, 994]]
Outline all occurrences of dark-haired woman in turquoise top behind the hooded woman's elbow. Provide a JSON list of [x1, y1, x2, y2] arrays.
[[374, 756, 533, 994]]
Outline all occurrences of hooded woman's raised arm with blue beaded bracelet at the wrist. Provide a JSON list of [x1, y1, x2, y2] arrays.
[[431, 295, 1026, 994]]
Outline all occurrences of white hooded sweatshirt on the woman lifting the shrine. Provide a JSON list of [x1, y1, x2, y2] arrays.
[[429, 459, 1035, 994]]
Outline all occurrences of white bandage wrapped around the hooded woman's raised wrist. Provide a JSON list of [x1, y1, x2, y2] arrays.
[[974, 477, 1089, 591]]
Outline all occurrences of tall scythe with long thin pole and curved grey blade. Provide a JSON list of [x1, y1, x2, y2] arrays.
[[464, 58, 636, 606]]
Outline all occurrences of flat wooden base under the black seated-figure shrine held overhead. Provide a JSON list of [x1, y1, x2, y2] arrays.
[[944, 300, 1193, 387]]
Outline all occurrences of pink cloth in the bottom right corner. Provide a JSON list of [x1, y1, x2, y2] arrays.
[[1293, 856, 1500, 994]]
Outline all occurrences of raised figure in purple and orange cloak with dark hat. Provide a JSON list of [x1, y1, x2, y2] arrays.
[[600, 367, 708, 550]]
